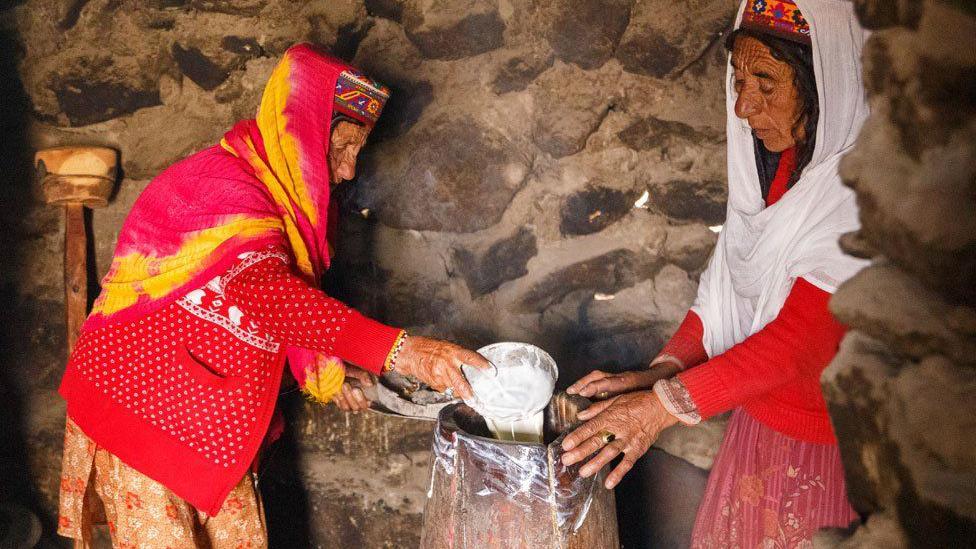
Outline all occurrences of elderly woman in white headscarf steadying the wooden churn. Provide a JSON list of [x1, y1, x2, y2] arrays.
[[563, 0, 867, 547]]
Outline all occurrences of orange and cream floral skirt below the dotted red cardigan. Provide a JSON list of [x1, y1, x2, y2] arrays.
[[58, 419, 268, 549]]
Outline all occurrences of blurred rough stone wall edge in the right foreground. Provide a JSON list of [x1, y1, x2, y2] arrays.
[[820, 0, 976, 549]]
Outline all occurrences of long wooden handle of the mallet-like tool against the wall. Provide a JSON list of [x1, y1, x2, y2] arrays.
[[64, 204, 88, 355]]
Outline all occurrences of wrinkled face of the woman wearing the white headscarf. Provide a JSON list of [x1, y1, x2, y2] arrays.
[[732, 36, 805, 152]]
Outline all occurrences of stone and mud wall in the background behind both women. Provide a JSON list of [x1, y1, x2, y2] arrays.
[[0, 0, 736, 547]]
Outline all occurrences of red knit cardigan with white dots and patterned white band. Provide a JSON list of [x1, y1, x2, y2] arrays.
[[60, 249, 399, 515]]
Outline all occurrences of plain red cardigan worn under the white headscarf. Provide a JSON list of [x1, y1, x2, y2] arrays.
[[662, 144, 845, 444]]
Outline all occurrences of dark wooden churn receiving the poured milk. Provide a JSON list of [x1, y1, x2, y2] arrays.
[[420, 393, 620, 549]]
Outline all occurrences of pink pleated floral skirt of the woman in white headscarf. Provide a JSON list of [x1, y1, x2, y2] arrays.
[[691, 408, 858, 549]]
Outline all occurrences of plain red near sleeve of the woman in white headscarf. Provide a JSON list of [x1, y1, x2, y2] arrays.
[[678, 278, 845, 419]]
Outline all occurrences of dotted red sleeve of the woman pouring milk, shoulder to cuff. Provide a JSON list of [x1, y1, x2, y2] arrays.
[[224, 258, 401, 374]]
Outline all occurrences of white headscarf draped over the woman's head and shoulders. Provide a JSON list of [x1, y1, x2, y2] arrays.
[[693, 0, 868, 356]]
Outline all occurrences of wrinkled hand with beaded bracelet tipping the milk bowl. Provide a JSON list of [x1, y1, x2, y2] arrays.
[[396, 336, 489, 398]]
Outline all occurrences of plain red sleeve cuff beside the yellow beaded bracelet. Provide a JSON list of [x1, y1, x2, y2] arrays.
[[333, 311, 403, 375]]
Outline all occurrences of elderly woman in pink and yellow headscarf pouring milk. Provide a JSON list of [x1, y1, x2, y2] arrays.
[[59, 45, 487, 547]]
